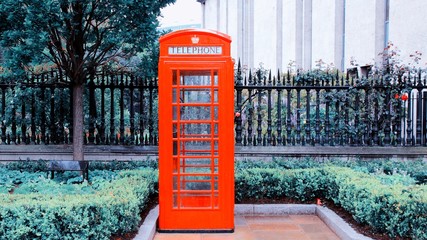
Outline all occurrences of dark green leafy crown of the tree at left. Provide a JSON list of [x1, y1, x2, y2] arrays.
[[0, 0, 174, 76]]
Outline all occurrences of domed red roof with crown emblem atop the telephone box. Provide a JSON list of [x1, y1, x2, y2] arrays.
[[159, 29, 231, 57]]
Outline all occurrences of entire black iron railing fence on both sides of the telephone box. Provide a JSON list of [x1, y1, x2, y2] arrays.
[[0, 68, 427, 146]]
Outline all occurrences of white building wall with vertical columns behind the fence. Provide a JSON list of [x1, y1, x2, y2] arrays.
[[203, 0, 427, 71]]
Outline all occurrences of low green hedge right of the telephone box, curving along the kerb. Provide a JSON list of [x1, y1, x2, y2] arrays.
[[235, 167, 427, 239]]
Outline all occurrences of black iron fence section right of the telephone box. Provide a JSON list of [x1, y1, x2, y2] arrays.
[[235, 65, 427, 146]]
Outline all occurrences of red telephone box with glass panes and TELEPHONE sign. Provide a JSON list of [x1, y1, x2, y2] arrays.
[[158, 29, 234, 232]]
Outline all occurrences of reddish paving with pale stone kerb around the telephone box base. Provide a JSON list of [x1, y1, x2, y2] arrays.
[[134, 204, 372, 240]]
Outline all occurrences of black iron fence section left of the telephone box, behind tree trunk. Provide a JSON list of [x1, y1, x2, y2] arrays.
[[0, 71, 157, 145]]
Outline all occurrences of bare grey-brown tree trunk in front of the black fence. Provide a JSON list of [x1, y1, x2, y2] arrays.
[[73, 84, 84, 161]]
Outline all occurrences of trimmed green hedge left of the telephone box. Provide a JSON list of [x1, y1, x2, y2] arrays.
[[0, 169, 157, 239]]
